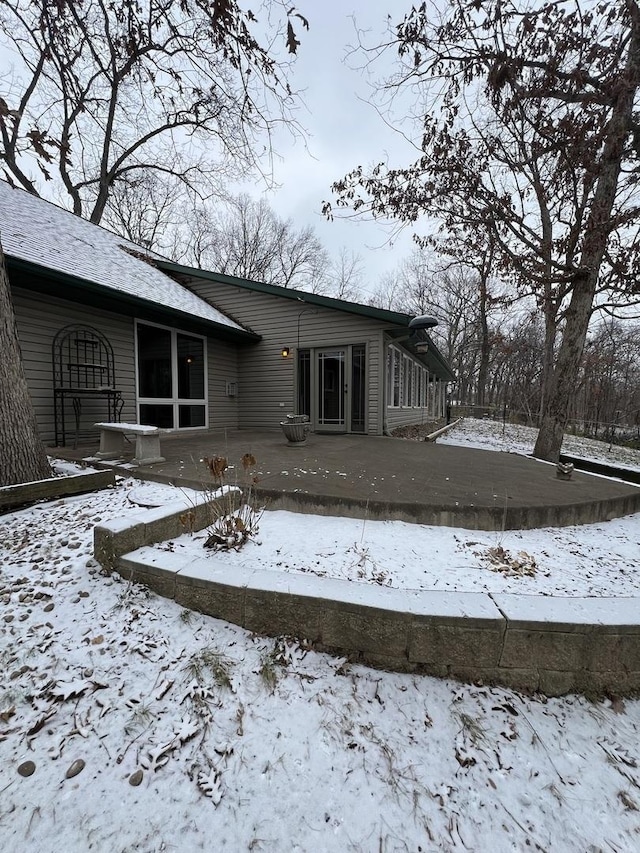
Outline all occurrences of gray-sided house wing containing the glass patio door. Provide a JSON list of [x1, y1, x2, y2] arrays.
[[159, 261, 455, 435]]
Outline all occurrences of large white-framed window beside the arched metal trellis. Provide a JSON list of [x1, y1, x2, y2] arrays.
[[136, 323, 207, 429]]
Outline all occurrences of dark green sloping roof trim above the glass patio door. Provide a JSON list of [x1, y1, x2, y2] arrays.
[[154, 259, 413, 327]]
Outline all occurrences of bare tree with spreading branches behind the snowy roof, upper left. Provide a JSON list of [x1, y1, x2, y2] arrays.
[[0, 0, 308, 223]]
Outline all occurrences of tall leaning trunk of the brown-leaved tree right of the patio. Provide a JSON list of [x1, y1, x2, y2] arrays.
[[533, 9, 640, 462]]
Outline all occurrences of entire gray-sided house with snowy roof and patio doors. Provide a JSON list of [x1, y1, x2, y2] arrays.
[[0, 182, 454, 444]]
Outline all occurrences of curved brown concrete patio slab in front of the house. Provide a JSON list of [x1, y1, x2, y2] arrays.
[[51, 430, 640, 530]]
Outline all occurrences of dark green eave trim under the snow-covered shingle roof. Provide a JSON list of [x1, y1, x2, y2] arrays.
[[7, 255, 260, 344]]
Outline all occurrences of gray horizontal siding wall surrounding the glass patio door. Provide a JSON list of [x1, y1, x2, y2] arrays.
[[190, 281, 385, 435]]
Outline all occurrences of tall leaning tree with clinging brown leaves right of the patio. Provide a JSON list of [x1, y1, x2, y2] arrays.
[[327, 0, 640, 460]]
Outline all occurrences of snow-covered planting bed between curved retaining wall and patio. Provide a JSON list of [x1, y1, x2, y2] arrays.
[[154, 512, 640, 596]]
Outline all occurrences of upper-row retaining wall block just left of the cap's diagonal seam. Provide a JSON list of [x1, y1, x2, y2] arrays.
[[408, 618, 504, 667]]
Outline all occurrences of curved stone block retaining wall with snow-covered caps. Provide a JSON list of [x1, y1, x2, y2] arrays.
[[94, 502, 640, 696]]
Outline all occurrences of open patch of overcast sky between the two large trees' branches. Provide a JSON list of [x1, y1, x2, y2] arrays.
[[252, 0, 422, 290]]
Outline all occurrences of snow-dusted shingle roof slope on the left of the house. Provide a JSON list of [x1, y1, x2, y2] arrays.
[[0, 181, 246, 332]]
